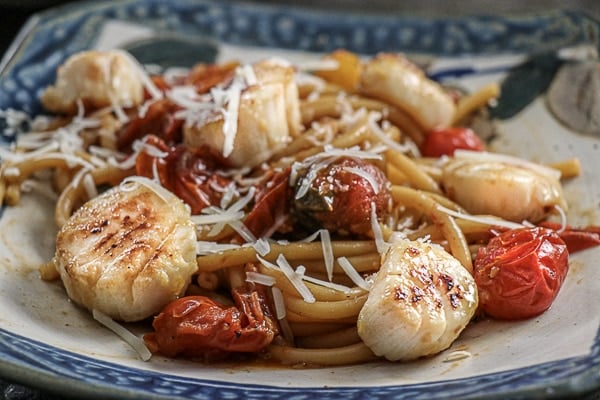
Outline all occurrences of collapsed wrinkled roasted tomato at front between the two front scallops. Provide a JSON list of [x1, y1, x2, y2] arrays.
[[144, 287, 278, 361]]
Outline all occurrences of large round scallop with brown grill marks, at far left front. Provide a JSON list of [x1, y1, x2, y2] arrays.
[[54, 178, 196, 321]]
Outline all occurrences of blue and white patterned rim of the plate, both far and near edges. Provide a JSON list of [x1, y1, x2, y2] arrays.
[[0, 0, 600, 400]]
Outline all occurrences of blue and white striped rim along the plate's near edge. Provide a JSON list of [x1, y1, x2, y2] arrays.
[[0, 329, 600, 400]]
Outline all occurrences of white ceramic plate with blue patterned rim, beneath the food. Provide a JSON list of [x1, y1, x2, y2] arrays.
[[0, 0, 600, 399]]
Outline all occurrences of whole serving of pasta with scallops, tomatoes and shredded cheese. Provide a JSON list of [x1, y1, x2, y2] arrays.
[[0, 50, 600, 367]]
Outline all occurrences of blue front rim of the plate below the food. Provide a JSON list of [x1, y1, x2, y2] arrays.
[[0, 328, 600, 400]]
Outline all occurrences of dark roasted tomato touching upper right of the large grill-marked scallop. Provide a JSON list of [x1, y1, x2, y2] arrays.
[[136, 136, 231, 214]]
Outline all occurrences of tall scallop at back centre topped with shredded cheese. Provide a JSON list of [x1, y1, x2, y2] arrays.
[[183, 60, 301, 167]]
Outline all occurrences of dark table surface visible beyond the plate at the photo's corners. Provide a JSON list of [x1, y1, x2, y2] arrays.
[[0, 0, 600, 400]]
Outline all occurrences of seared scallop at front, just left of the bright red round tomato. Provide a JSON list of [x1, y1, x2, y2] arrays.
[[357, 240, 478, 361]]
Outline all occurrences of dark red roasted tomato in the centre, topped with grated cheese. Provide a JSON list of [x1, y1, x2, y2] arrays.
[[294, 157, 391, 235]]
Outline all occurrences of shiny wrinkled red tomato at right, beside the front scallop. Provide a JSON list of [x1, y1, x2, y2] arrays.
[[473, 227, 569, 320]]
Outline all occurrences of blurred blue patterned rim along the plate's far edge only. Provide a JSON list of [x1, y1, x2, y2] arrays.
[[0, 0, 600, 112]]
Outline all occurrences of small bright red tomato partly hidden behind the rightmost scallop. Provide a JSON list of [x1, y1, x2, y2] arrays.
[[421, 127, 485, 157]]
